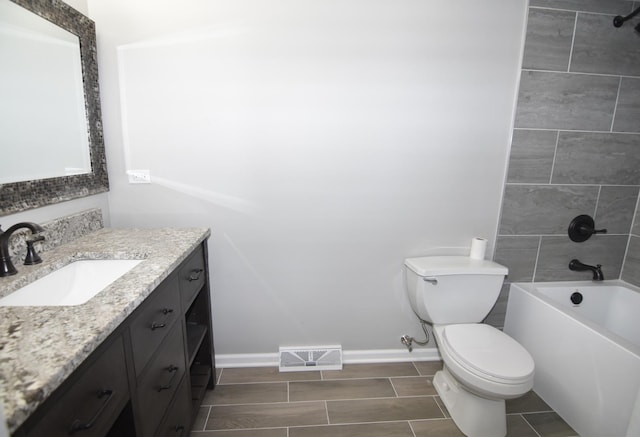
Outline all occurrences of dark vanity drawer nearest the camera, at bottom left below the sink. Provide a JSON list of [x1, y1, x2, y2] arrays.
[[26, 336, 129, 437]]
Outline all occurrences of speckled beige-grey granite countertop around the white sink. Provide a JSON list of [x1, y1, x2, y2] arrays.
[[0, 228, 210, 432]]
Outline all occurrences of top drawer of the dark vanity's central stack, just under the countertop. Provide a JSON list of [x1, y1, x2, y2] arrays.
[[129, 275, 180, 375]]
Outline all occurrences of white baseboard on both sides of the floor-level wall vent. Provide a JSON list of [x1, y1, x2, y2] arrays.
[[216, 348, 440, 368]]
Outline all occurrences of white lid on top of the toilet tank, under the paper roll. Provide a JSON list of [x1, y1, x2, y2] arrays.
[[404, 256, 509, 276]]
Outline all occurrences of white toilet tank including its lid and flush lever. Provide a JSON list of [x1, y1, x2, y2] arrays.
[[404, 256, 508, 325]]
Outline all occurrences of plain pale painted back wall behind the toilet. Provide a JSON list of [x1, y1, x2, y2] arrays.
[[88, 0, 526, 362]]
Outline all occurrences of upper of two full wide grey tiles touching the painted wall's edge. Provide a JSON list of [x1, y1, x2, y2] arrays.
[[515, 71, 620, 131]]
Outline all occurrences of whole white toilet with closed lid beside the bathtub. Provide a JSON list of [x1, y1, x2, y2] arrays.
[[405, 256, 534, 437]]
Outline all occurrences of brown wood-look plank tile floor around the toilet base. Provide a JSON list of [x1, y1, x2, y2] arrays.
[[191, 362, 577, 437]]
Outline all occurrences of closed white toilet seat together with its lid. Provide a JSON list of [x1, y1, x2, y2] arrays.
[[434, 323, 535, 399]]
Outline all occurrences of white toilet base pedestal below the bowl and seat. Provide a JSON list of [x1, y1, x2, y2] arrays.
[[433, 366, 507, 437]]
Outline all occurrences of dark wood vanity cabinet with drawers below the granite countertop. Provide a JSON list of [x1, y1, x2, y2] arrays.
[[14, 241, 215, 437]]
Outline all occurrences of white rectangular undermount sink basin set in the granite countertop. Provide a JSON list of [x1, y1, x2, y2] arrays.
[[0, 259, 142, 306]]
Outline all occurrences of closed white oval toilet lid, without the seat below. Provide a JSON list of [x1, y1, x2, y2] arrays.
[[443, 324, 534, 383]]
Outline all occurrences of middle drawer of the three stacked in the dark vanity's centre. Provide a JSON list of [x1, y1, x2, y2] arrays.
[[136, 323, 185, 437]]
